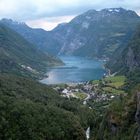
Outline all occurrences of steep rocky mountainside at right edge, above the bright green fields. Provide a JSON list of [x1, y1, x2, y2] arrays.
[[107, 26, 140, 73]]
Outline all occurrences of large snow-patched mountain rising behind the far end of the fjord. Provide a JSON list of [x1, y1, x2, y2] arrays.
[[52, 8, 140, 57]]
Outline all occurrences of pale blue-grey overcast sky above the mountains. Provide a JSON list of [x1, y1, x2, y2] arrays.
[[0, 0, 140, 30]]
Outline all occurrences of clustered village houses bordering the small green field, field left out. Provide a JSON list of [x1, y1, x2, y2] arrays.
[[54, 82, 115, 105]]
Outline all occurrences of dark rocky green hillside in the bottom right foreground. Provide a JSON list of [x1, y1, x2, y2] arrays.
[[91, 85, 140, 140]]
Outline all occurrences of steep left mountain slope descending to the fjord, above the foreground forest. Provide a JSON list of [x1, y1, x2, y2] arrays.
[[0, 24, 62, 77]]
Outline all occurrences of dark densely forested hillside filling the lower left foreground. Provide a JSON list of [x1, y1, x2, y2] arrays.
[[0, 75, 94, 140]]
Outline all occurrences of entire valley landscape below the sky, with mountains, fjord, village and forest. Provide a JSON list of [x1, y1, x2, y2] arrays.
[[0, 8, 140, 140]]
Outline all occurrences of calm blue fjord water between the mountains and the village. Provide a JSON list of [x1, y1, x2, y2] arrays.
[[41, 56, 105, 84]]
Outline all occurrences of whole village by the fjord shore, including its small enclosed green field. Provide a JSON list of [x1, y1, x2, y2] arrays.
[[53, 82, 115, 105]]
